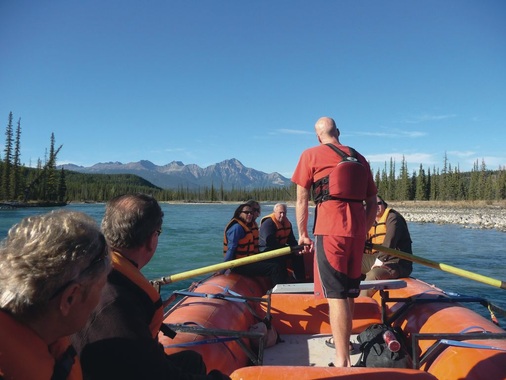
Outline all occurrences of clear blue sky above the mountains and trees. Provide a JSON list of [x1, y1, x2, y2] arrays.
[[0, 0, 506, 177]]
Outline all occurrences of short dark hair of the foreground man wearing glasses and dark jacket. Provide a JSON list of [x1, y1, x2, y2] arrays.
[[102, 194, 163, 248]]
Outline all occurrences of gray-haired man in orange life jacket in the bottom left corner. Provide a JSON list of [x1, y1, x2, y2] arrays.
[[0, 211, 111, 380]]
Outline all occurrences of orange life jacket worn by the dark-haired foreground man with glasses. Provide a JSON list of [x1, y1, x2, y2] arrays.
[[111, 252, 163, 338]]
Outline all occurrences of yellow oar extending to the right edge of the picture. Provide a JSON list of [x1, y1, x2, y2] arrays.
[[371, 244, 506, 289]]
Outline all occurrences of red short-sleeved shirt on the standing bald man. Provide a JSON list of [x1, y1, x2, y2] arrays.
[[292, 144, 377, 238]]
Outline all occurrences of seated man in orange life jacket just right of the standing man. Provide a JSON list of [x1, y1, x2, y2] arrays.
[[360, 196, 413, 297]]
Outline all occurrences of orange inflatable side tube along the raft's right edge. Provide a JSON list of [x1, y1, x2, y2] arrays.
[[374, 278, 506, 380]]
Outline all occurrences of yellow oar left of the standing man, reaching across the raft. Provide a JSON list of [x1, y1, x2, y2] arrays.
[[151, 245, 304, 286]]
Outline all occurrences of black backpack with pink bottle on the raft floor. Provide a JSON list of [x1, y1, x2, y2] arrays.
[[355, 324, 413, 368]]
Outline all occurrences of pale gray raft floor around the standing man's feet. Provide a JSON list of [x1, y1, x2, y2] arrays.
[[263, 334, 360, 367]]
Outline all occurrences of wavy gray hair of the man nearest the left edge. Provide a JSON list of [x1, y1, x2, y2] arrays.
[[0, 210, 111, 318]]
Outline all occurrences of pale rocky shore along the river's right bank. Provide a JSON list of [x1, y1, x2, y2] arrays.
[[389, 201, 506, 232]]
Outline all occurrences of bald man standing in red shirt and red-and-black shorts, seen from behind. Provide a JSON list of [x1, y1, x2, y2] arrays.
[[292, 117, 377, 367]]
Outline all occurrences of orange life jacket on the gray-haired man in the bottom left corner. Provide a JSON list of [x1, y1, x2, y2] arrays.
[[0, 310, 83, 380]]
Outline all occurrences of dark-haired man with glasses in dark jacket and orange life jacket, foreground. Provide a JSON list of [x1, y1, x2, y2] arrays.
[[73, 194, 228, 380]]
